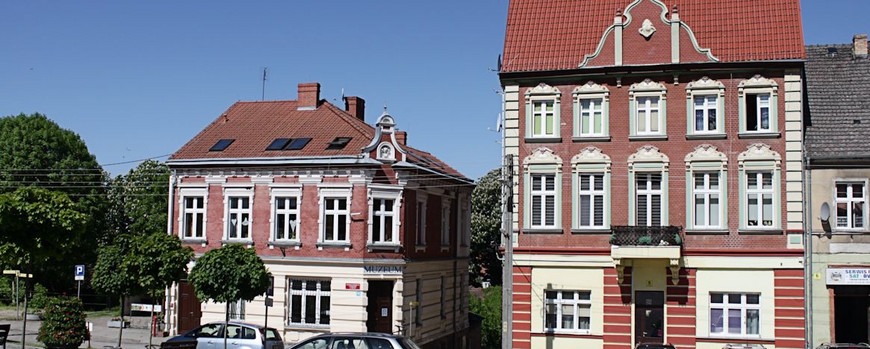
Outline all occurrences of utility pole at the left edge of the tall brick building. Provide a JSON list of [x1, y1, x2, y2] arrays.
[[501, 154, 514, 349]]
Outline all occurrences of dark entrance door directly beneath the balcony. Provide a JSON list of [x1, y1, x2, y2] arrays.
[[634, 291, 665, 344]]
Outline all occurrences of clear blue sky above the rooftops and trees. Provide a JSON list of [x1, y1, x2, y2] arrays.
[[0, 0, 870, 178]]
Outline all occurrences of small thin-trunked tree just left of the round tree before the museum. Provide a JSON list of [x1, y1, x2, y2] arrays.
[[125, 233, 193, 345]]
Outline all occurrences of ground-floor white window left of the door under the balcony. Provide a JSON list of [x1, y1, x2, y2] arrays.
[[544, 291, 592, 332]]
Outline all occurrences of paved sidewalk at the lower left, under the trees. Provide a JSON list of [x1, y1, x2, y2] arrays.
[[0, 310, 167, 349]]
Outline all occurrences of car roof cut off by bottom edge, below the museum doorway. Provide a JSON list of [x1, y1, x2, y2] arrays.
[[290, 333, 420, 349]]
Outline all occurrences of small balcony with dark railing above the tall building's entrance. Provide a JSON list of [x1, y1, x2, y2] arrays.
[[610, 226, 683, 260]]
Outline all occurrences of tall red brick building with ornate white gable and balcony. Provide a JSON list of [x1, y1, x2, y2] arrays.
[[500, 0, 805, 349]]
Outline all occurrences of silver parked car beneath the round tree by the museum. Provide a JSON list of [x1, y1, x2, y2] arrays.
[[165, 321, 284, 349]]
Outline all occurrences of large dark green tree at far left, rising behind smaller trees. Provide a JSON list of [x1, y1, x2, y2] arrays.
[[0, 113, 109, 290]]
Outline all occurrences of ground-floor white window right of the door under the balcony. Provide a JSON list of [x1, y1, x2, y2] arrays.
[[710, 292, 761, 336]]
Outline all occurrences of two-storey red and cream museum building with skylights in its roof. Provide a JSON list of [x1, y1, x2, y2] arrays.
[[167, 83, 474, 347]]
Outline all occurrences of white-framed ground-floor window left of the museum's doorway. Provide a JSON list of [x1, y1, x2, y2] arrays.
[[287, 279, 332, 326]]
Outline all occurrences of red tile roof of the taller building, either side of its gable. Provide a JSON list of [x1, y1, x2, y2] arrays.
[[502, 0, 805, 72]]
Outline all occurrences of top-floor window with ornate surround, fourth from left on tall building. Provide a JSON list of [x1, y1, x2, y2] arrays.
[[686, 76, 725, 138]]
